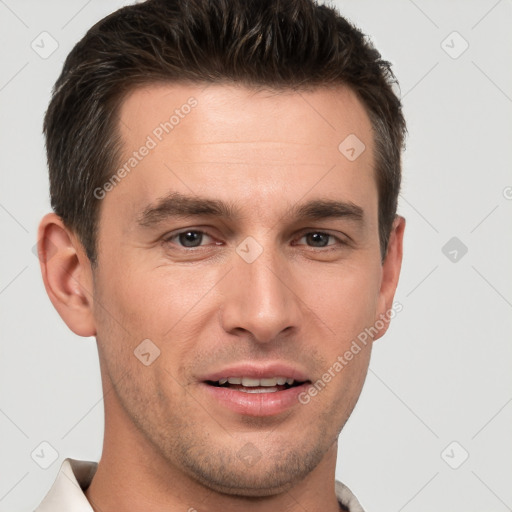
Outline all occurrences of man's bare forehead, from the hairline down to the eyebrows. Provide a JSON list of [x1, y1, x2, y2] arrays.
[[108, 84, 376, 222]]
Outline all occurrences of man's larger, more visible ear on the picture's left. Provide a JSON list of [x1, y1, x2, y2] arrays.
[[37, 213, 96, 336]]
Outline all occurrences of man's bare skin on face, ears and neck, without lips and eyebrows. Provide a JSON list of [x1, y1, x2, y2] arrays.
[[39, 84, 405, 512]]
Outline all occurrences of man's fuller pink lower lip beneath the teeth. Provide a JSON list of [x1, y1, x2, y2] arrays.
[[202, 383, 310, 417]]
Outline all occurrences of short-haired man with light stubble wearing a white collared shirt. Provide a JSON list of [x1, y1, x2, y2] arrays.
[[37, 0, 405, 512]]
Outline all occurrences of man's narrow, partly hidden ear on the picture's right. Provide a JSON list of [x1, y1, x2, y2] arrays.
[[374, 215, 405, 339]]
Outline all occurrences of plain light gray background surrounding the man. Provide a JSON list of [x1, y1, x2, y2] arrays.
[[0, 0, 512, 512]]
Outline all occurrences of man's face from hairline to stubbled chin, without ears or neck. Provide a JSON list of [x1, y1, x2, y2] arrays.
[[94, 84, 390, 494]]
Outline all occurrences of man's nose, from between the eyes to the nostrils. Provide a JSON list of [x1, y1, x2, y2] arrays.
[[220, 245, 302, 344]]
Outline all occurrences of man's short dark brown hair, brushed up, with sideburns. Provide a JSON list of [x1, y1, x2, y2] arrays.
[[44, 0, 406, 264]]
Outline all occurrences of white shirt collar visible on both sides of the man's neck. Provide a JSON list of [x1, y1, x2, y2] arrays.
[[34, 459, 364, 512]]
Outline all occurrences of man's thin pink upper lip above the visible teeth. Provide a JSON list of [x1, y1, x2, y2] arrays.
[[199, 361, 308, 382]]
